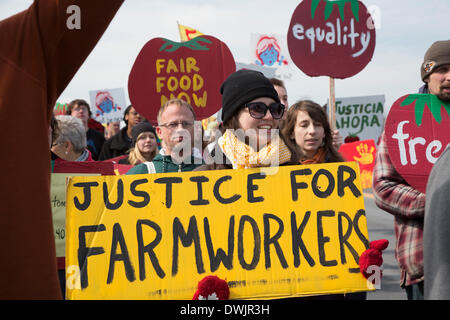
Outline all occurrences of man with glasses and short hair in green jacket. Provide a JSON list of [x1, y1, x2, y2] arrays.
[[127, 99, 203, 174]]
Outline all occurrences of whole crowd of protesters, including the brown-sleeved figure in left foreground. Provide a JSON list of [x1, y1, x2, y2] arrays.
[[0, 0, 450, 299]]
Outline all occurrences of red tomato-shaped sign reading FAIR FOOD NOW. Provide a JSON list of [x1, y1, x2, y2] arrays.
[[128, 36, 236, 122]]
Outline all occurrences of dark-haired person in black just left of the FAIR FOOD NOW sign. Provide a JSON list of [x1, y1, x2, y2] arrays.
[[98, 105, 143, 161]]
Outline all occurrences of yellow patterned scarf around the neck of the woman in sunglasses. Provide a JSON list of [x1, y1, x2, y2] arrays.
[[217, 130, 291, 169]]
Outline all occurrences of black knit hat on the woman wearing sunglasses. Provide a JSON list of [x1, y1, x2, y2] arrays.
[[220, 70, 280, 122]]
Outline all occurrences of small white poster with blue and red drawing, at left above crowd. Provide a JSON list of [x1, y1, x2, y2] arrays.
[[89, 88, 127, 124]]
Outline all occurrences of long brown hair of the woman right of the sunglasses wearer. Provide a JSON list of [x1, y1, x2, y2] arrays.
[[281, 100, 344, 162]]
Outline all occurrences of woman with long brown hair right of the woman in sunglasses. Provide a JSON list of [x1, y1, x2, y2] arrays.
[[281, 100, 344, 164]]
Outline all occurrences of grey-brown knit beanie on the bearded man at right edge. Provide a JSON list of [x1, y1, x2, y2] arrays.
[[420, 40, 450, 82]]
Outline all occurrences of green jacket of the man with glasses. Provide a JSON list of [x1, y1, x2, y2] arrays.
[[127, 154, 204, 174]]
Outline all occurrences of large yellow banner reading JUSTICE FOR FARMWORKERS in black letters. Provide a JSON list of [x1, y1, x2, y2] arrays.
[[66, 163, 374, 299]]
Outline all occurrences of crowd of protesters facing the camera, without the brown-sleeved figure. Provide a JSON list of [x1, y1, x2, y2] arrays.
[[46, 41, 450, 299]]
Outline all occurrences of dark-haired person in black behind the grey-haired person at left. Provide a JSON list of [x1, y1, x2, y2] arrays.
[[66, 99, 105, 160]]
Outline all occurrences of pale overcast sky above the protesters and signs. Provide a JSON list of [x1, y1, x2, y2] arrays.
[[0, 0, 450, 115]]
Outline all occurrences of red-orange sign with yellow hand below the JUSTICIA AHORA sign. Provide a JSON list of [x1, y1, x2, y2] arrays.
[[339, 140, 377, 189]]
